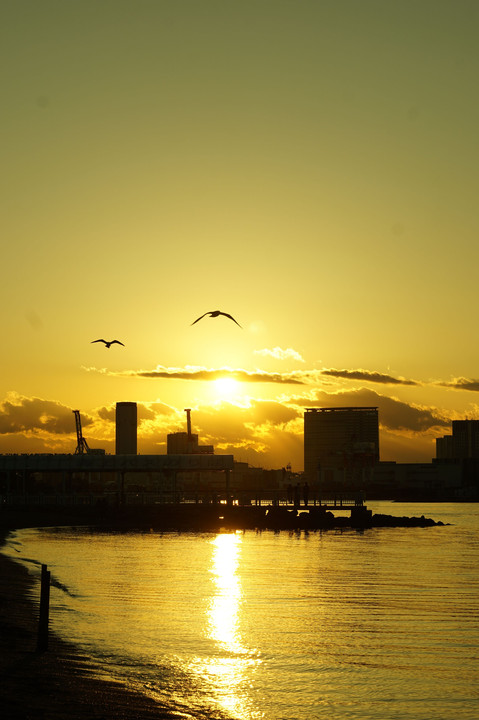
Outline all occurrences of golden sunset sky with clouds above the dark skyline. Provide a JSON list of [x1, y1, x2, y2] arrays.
[[0, 0, 479, 470]]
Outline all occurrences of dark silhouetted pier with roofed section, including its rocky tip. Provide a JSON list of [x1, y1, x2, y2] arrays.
[[0, 454, 444, 532]]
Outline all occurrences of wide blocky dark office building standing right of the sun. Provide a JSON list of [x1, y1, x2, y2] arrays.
[[304, 407, 379, 483]]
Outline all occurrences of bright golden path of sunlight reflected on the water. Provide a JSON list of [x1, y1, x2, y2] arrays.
[[189, 533, 263, 720]]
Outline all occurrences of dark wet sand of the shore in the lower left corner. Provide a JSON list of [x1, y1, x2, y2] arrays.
[[0, 530, 178, 720]]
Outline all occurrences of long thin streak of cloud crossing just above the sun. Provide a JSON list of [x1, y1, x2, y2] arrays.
[[84, 365, 313, 385]]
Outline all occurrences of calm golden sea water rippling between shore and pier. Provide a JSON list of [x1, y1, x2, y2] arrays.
[[4, 503, 479, 720]]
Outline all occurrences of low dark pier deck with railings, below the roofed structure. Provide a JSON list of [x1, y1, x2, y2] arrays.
[[0, 491, 372, 532]]
